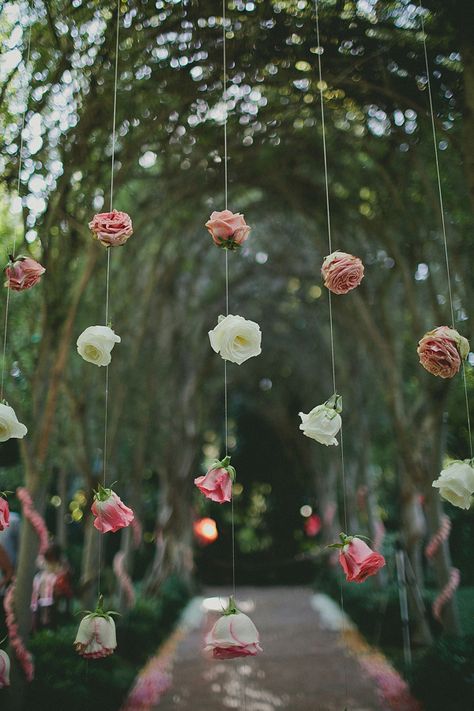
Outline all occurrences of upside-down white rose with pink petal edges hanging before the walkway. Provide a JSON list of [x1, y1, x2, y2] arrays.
[[205, 597, 262, 659]]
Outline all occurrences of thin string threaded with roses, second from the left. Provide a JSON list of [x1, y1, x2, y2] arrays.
[[98, 0, 120, 595]]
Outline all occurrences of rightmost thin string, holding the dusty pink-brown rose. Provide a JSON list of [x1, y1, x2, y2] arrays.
[[419, 0, 474, 459]]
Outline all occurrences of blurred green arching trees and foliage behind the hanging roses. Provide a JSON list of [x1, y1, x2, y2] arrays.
[[0, 0, 474, 711]]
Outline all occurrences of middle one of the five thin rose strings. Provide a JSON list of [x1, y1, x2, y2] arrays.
[[222, 0, 235, 599]]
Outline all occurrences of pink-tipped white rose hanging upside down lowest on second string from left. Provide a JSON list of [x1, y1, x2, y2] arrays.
[[74, 595, 117, 659]]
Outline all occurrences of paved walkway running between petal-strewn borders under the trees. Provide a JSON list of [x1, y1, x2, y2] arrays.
[[157, 587, 382, 711]]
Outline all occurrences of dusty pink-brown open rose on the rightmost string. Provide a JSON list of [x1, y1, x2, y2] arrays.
[[417, 326, 469, 378]]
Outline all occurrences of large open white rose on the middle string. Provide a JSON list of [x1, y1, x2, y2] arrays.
[[209, 314, 262, 365]]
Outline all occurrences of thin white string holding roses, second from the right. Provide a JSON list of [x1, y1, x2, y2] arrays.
[[314, 0, 349, 709]]
